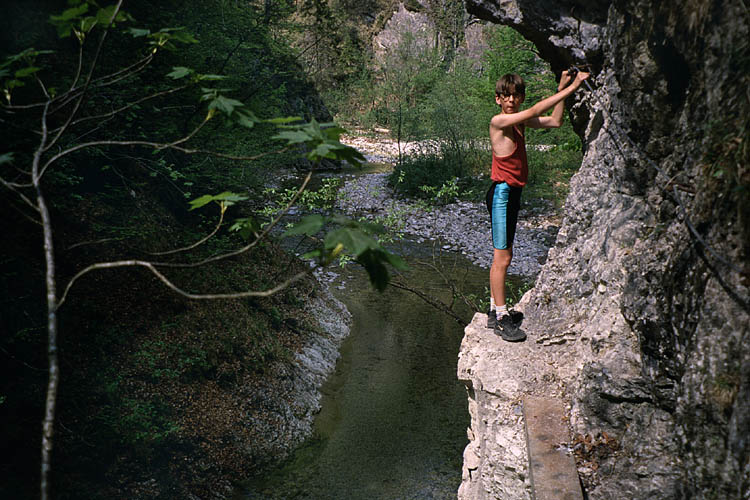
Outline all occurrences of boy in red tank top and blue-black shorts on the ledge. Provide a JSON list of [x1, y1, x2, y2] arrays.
[[487, 71, 589, 342]]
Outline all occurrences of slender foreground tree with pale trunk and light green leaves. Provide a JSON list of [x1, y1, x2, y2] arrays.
[[0, 0, 403, 499]]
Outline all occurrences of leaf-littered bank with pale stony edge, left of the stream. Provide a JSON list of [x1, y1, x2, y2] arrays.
[[100, 278, 351, 500]]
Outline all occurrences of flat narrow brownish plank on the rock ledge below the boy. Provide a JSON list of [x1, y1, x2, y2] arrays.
[[523, 397, 583, 500]]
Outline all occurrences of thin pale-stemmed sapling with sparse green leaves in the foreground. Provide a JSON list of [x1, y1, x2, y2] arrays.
[[0, 0, 396, 500]]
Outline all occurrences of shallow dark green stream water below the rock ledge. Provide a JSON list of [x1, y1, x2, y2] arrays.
[[240, 256, 487, 499]]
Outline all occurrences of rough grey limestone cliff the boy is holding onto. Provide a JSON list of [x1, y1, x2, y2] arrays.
[[459, 0, 750, 499]]
